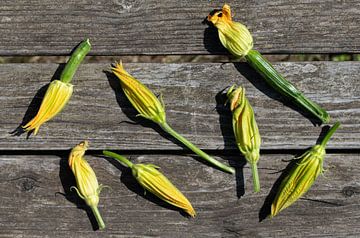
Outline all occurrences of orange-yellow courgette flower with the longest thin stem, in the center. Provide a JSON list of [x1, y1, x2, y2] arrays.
[[111, 62, 235, 174]]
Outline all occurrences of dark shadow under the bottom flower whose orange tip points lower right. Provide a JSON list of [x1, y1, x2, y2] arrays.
[[97, 154, 189, 217]]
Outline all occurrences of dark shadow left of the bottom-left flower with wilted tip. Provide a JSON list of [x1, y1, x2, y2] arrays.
[[58, 156, 99, 230]]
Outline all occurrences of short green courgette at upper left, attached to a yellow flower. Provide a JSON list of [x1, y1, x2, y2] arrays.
[[60, 39, 91, 83]]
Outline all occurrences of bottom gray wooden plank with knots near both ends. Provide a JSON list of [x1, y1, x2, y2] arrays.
[[0, 154, 360, 237]]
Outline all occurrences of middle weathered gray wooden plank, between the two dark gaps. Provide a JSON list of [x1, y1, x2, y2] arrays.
[[0, 62, 360, 150]]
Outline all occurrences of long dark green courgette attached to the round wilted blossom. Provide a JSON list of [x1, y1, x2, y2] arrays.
[[245, 50, 330, 123]]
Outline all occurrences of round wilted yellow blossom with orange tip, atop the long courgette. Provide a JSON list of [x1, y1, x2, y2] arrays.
[[208, 4, 253, 57]]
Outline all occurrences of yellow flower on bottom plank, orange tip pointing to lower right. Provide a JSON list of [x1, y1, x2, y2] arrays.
[[103, 151, 196, 217]]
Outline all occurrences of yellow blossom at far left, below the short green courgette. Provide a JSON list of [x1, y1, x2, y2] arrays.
[[23, 80, 73, 135]]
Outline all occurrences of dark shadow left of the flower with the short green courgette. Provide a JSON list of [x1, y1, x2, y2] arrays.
[[9, 64, 65, 139]]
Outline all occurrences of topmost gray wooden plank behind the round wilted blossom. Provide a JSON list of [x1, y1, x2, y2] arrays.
[[0, 0, 360, 55]]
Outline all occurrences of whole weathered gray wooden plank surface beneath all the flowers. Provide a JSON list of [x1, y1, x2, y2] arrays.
[[0, 0, 360, 238]]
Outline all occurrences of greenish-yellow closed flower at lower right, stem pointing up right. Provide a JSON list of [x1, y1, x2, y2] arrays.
[[271, 122, 340, 217]]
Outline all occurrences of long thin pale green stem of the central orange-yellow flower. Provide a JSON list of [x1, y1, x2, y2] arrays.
[[159, 122, 235, 174]]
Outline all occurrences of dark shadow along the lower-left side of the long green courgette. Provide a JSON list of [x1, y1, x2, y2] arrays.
[[234, 63, 322, 126]]
